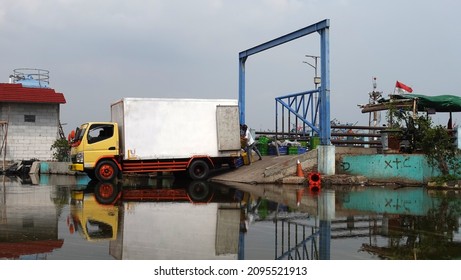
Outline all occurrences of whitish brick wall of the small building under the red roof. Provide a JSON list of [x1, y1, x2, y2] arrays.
[[0, 103, 59, 160]]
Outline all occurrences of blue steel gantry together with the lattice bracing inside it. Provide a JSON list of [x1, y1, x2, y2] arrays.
[[239, 19, 331, 145]]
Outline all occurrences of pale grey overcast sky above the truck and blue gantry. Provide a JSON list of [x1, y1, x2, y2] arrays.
[[0, 0, 461, 133]]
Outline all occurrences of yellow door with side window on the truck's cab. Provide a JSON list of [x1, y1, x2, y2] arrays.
[[85, 124, 119, 166]]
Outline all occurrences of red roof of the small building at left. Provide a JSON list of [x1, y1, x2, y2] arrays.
[[0, 83, 66, 104]]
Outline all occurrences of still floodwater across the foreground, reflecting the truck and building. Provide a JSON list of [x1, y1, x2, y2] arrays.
[[0, 175, 461, 260]]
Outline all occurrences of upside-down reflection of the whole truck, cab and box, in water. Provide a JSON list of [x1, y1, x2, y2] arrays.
[[72, 181, 241, 259]]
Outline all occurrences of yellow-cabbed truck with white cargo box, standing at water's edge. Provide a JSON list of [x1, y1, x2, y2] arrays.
[[69, 98, 241, 182]]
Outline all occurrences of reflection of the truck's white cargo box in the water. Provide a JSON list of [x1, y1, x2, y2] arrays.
[[109, 198, 241, 260]]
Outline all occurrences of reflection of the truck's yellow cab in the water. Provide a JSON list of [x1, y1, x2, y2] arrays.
[[67, 191, 118, 241]]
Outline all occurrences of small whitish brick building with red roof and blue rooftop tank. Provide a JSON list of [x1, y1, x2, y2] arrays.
[[0, 68, 66, 161]]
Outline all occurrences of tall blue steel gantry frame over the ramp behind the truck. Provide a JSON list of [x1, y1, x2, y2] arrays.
[[239, 19, 331, 145]]
